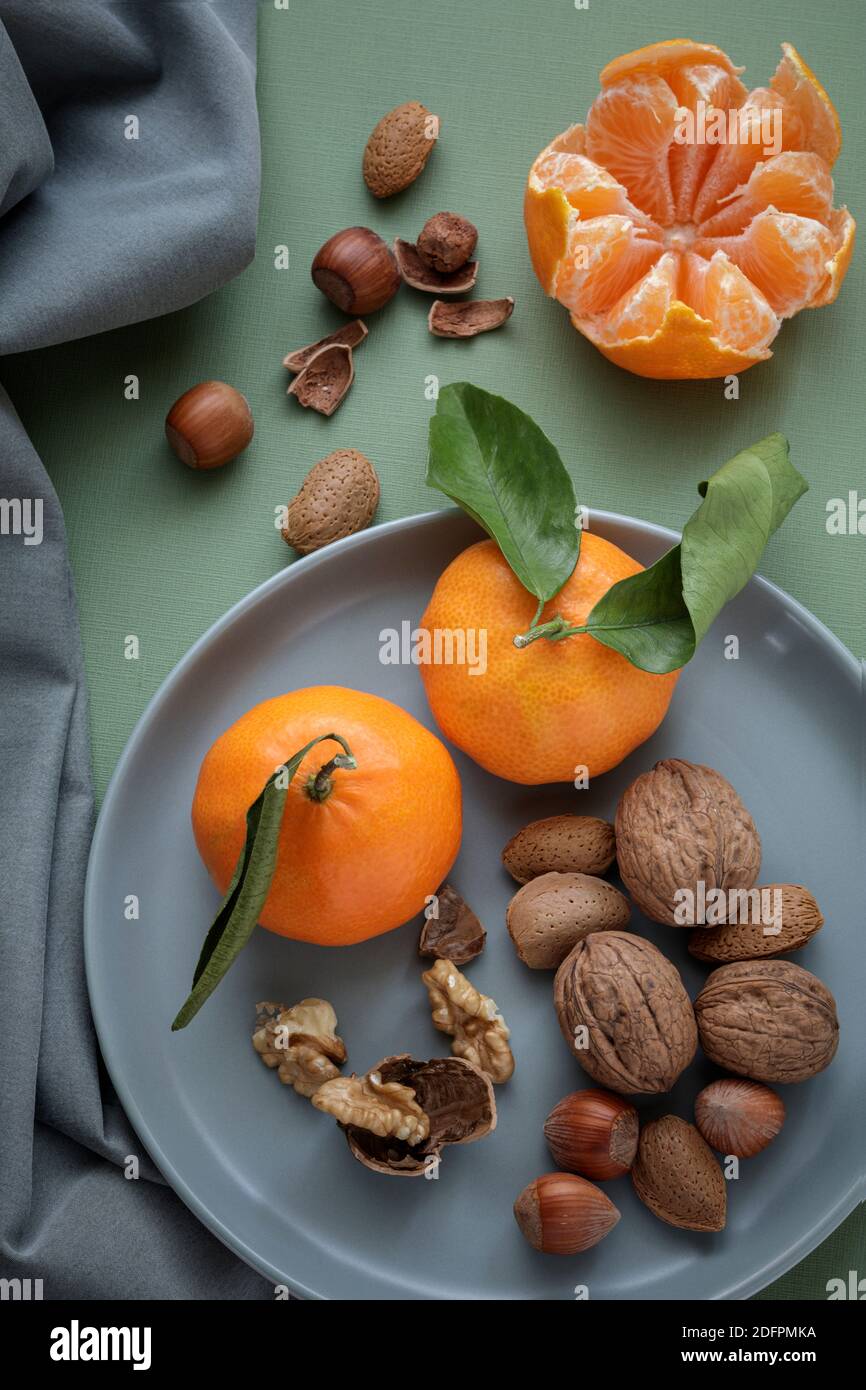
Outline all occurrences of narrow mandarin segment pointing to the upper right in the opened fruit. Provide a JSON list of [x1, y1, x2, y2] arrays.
[[692, 88, 802, 224]]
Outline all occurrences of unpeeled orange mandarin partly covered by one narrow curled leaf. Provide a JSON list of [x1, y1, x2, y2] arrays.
[[192, 685, 461, 947]]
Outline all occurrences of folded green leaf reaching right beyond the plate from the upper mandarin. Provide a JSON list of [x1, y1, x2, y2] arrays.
[[585, 434, 809, 674]]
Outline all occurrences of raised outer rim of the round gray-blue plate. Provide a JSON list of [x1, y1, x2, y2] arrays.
[[83, 506, 866, 1301]]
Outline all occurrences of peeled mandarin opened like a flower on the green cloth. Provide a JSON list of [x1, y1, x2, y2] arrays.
[[524, 39, 855, 378]]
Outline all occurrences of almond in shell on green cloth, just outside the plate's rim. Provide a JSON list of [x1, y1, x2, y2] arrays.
[[281, 449, 379, 555]]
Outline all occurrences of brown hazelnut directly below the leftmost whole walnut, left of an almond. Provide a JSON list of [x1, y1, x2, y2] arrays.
[[545, 1090, 638, 1182]]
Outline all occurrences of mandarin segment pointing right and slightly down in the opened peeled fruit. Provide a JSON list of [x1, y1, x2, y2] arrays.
[[695, 207, 837, 318]]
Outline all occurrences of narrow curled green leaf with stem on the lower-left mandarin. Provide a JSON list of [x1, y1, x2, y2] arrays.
[[171, 734, 354, 1033]]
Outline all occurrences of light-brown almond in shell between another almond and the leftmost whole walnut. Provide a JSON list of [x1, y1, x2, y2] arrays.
[[505, 873, 630, 970]]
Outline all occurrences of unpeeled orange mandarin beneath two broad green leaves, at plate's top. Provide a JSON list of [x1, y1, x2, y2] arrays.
[[420, 531, 680, 785]]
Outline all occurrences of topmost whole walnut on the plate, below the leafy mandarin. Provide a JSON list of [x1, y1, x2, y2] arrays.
[[616, 758, 760, 927]]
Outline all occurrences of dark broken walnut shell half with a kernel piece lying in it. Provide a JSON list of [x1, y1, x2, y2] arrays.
[[335, 1054, 496, 1177]]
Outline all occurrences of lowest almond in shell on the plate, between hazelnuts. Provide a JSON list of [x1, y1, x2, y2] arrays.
[[631, 1115, 727, 1230]]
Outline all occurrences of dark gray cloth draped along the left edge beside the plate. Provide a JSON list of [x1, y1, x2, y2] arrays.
[[0, 0, 272, 1300]]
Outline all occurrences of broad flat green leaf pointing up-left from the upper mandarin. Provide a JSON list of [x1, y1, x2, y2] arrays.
[[427, 381, 580, 602]]
